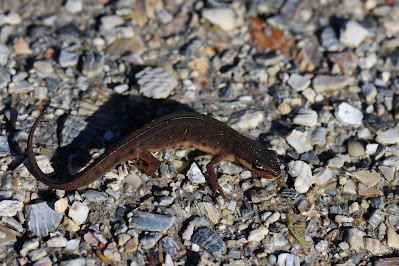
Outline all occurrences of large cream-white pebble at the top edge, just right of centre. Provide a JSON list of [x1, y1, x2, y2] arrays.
[[202, 8, 238, 31]]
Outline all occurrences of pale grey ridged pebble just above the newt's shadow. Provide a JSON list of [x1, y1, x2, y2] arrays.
[[135, 67, 178, 99]]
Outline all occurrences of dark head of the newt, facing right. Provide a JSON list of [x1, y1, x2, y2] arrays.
[[234, 139, 281, 179]]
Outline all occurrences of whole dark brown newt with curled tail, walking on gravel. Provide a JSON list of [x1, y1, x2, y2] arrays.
[[27, 112, 281, 197]]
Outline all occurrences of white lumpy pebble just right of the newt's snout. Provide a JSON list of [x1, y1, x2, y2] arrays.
[[288, 161, 313, 193]]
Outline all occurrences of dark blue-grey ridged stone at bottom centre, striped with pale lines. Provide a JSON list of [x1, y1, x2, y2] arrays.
[[191, 227, 226, 256]]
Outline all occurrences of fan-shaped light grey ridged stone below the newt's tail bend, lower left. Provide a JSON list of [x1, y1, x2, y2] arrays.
[[25, 202, 63, 237]]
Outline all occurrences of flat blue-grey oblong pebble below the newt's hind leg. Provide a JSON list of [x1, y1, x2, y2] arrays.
[[129, 211, 175, 233]]
